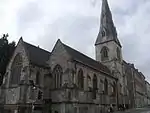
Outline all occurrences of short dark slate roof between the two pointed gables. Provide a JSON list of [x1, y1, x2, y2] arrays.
[[24, 42, 51, 68]]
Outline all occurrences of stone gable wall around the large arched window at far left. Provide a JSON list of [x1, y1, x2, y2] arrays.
[[3, 40, 29, 104]]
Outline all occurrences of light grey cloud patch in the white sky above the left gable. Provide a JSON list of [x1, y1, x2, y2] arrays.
[[17, 1, 44, 31]]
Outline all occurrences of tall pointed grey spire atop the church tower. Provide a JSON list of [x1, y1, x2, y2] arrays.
[[95, 0, 121, 47]]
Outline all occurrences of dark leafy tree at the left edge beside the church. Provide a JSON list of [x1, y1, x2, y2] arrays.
[[0, 34, 16, 85]]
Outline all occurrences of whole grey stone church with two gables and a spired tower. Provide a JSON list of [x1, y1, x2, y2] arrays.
[[0, 0, 148, 113]]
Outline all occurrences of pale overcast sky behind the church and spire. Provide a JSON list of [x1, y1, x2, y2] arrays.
[[0, 0, 150, 81]]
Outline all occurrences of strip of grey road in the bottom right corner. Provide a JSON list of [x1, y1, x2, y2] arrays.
[[115, 108, 150, 113]]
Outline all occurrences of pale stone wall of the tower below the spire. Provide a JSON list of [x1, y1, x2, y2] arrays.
[[95, 41, 126, 104]]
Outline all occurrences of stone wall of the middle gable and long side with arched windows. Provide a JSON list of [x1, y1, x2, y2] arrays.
[[49, 42, 116, 113]]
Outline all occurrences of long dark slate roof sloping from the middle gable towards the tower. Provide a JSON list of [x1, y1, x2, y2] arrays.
[[63, 44, 110, 74]]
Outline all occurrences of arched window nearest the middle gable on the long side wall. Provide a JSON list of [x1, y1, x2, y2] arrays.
[[78, 69, 84, 89]]
